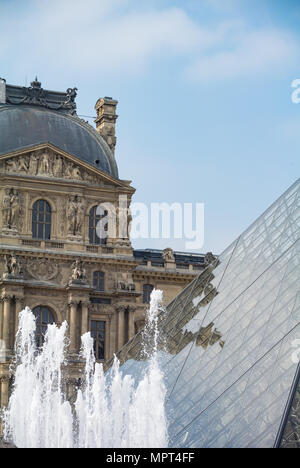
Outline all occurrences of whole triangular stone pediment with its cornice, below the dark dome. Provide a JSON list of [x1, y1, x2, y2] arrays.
[[0, 144, 134, 191]]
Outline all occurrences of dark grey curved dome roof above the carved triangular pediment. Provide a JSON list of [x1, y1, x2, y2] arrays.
[[0, 105, 118, 179]]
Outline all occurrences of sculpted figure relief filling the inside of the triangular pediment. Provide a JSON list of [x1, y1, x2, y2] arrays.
[[0, 149, 109, 186]]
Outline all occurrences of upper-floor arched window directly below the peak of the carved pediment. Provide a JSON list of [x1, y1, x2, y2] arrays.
[[32, 200, 51, 240]]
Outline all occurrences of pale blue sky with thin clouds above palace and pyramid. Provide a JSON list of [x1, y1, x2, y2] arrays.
[[0, 0, 300, 254]]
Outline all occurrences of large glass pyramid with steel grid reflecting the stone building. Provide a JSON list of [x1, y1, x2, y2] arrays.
[[114, 179, 300, 448]]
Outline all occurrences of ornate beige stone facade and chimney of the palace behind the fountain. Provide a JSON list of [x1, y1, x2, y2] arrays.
[[0, 79, 212, 432]]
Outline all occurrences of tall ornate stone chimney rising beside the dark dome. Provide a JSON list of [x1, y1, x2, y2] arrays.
[[95, 97, 118, 153]]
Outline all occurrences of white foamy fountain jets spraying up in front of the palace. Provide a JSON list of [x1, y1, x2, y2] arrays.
[[4, 291, 168, 448]]
